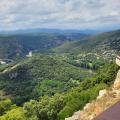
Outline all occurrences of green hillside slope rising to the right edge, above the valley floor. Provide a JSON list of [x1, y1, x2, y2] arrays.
[[53, 30, 120, 58]]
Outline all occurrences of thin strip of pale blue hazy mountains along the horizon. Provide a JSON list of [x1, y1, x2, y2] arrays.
[[0, 28, 102, 35]]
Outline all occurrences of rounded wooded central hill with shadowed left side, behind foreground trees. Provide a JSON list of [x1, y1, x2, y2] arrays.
[[0, 55, 93, 104]]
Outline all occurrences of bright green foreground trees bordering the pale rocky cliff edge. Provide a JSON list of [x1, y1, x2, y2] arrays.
[[0, 63, 118, 120]]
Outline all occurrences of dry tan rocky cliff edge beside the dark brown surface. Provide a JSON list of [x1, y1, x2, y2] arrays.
[[65, 63, 120, 120]]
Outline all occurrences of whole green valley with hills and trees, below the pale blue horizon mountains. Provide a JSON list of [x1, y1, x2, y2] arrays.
[[0, 31, 120, 120]]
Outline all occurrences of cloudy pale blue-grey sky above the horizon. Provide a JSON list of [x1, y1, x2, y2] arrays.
[[0, 0, 120, 30]]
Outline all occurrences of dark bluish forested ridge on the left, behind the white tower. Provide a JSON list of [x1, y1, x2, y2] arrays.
[[0, 33, 86, 58]]
